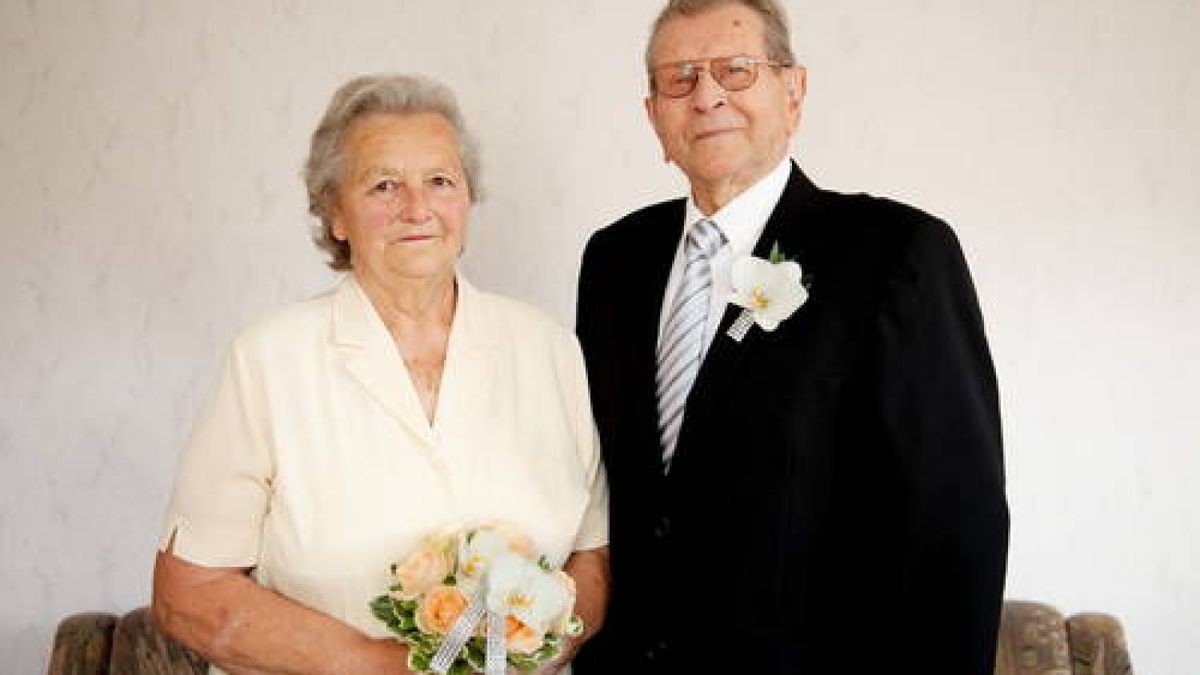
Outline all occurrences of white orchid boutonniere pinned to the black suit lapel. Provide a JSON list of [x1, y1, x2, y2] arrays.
[[727, 243, 809, 342]]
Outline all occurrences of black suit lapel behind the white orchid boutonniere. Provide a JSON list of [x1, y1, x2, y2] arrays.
[[676, 162, 816, 461]]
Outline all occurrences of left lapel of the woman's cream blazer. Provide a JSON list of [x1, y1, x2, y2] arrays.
[[332, 275, 433, 447]]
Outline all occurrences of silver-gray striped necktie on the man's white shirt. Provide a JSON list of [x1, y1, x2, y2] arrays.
[[655, 219, 725, 472]]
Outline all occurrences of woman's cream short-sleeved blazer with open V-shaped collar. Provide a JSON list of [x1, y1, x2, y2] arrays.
[[160, 275, 608, 637]]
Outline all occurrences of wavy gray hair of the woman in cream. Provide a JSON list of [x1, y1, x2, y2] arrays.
[[304, 74, 482, 270]]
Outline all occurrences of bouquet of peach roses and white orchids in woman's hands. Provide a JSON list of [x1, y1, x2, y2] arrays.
[[371, 525, 583, 675]]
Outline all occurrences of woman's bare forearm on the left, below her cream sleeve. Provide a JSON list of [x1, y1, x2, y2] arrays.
[[152, 552, 408, 675]]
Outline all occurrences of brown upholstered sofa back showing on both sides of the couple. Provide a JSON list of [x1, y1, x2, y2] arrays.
[[48, 601, 1133, 675]]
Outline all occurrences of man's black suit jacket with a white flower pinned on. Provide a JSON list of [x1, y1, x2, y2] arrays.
[[576, 165, 1008, 675]]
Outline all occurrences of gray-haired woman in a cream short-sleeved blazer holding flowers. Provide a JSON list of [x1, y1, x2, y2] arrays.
[[154, 76, 607, 675]]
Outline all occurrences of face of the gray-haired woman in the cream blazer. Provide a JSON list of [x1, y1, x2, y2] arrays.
[[332, 113, 470, 285]]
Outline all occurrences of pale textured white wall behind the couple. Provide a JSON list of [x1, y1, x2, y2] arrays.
[[0, 0, 1200, 674]]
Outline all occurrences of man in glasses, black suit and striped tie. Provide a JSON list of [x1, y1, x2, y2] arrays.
[[576, 0, 1008, 675]]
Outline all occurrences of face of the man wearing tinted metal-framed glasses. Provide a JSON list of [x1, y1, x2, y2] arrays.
[[646, 5, 804, 208]]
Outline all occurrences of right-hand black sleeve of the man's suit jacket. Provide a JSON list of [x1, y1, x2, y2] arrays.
[[877, 220, 1008, 675]]
